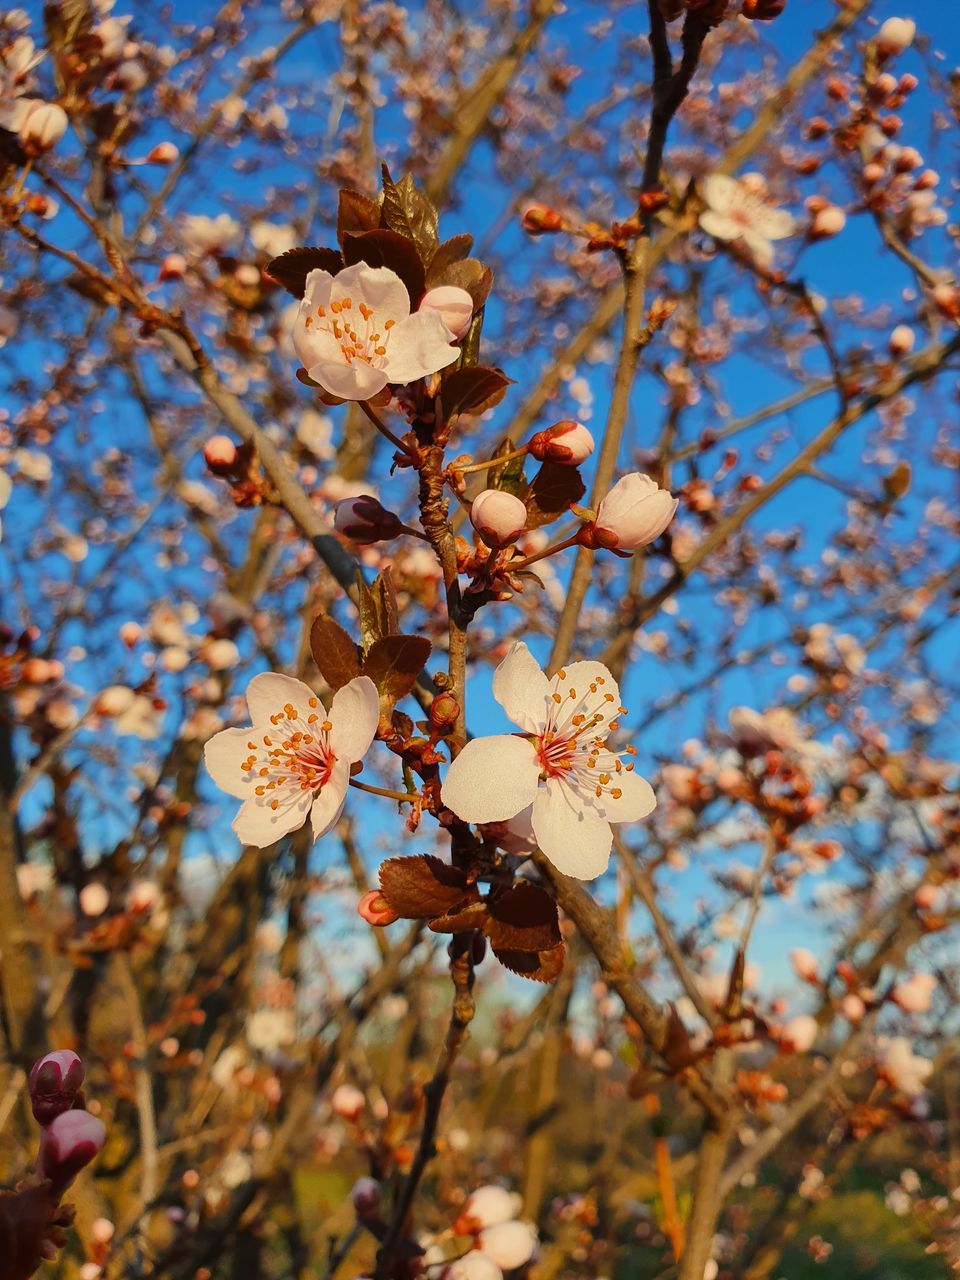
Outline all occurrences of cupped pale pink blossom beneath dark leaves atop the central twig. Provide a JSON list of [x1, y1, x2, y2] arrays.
[[293, 262, 460, 401]]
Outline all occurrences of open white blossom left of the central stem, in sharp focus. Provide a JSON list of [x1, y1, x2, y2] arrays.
[[204, 671, 380, 849]]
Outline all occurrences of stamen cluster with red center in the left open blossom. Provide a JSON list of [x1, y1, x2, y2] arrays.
[[241, 698, 337, 809]]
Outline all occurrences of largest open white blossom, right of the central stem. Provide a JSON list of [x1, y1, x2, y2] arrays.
[[440, 641, 657, 879]]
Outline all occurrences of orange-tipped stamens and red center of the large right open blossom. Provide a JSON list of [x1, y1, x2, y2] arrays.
[[534, 668, 636, 800]]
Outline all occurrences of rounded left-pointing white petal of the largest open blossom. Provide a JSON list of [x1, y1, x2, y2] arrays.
[[440, 733, 540, 822]]
